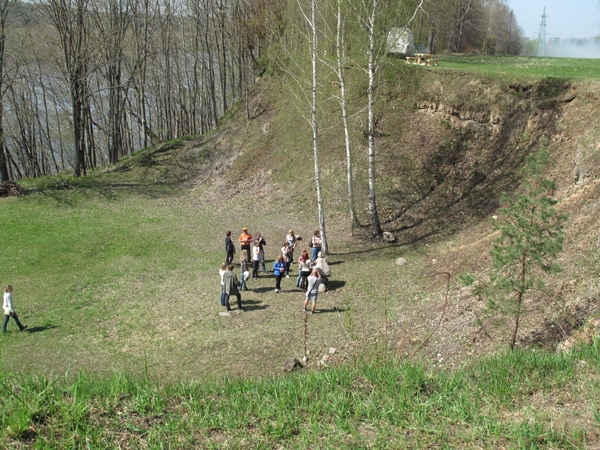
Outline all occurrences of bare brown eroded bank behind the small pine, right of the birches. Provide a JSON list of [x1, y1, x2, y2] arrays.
[[376, 74, 600, 366]]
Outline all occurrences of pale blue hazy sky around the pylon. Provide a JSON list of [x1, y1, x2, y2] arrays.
[[508, 0, 600, 39]]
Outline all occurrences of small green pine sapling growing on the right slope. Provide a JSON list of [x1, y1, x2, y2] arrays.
[[460, 146, 567, 349]]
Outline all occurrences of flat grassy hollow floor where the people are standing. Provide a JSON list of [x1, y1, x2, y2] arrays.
[[0, 156, 426, 380]]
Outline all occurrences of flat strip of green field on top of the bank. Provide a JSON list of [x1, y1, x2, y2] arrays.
[[428, 55, 600, 80]]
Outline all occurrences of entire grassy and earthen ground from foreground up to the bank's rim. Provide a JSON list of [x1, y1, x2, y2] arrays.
[[0, 57, 600, 448]]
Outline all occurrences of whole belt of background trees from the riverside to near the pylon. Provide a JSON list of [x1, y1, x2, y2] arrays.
[[0, 0, 523, 180]]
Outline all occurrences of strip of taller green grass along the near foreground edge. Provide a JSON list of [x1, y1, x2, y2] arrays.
[[0, 343, 600, 449]]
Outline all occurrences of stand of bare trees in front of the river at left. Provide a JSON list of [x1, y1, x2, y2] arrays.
[[0, 0, 274, 179]]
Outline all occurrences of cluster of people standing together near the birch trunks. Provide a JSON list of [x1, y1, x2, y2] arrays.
[[219, 227, 330, 314]]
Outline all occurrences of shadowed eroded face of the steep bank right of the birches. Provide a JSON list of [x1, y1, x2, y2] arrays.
[[380, 73, 577, 241]]
